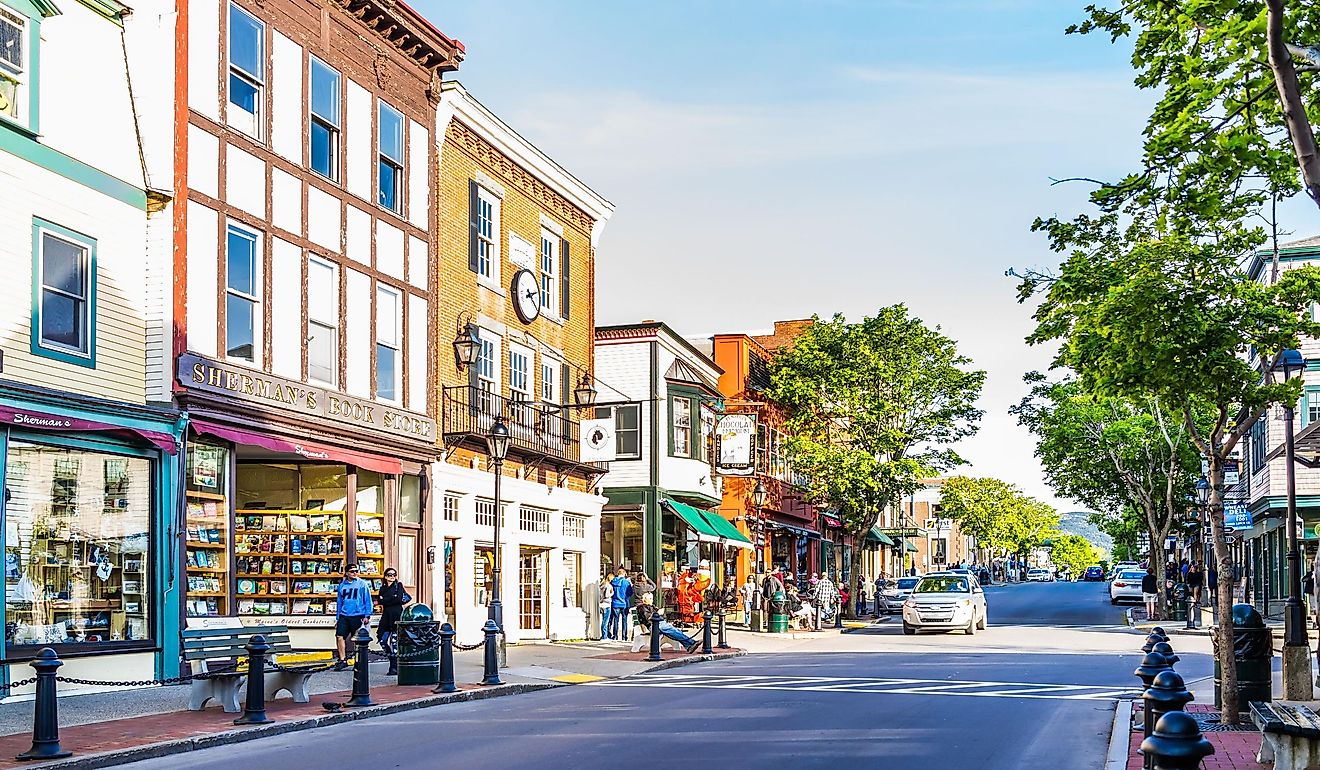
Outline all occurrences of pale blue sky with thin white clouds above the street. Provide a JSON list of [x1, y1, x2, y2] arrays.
[[413, 0, 1320, 510]]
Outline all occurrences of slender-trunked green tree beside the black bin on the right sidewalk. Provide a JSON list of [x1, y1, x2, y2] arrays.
[[1023, 230, 1320, 724]]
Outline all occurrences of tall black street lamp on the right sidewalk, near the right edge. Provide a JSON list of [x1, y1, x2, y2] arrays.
[[1274, 350, 1312, 700]]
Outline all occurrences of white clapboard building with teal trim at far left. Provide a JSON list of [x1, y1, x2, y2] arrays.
[[0, 0, 182, 695]]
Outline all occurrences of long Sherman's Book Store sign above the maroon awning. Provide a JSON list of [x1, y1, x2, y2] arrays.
[[178, 353, 436, 442]]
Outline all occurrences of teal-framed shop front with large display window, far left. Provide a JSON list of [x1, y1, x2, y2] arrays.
[[0, 384, 182, 695]]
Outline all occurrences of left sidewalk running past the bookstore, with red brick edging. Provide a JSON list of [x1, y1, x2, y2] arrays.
[[0, 629, 847, 770]]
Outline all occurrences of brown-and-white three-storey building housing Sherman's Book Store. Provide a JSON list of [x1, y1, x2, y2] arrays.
[[168, 0, 463, 647]]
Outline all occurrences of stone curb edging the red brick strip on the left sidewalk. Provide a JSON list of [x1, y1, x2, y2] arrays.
[[21, 683, 566, 770]]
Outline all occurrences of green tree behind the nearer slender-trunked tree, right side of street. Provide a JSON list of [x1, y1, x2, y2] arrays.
[[1010, 372, 1201, 601]]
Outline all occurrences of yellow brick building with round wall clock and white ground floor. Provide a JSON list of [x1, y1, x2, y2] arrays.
[[433, 82, 614, 643]]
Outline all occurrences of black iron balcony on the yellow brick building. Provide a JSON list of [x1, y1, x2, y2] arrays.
[[441, 386, 607, 473]]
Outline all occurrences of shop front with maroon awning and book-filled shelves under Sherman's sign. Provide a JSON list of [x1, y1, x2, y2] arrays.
[[181, 362, 434, 648]]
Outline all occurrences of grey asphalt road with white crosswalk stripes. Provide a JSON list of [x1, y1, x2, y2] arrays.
[[127, 584, 1210, 770]]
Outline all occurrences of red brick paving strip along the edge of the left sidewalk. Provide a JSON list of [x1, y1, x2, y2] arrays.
[[0, 684, 480, 767]]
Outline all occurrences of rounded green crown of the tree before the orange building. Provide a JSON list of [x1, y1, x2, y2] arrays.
[[764, 305, 985, 536]]
